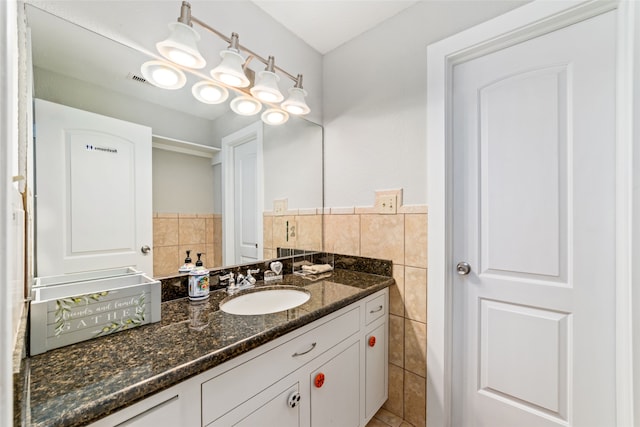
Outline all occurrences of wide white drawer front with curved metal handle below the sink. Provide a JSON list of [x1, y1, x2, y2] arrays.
[[202, 306, 360, 425]]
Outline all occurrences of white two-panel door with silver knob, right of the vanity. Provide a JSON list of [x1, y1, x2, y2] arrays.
[[452, 11, 616, 427]]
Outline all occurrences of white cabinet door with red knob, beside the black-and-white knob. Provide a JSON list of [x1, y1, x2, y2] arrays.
[[310, 342, 360, 427]]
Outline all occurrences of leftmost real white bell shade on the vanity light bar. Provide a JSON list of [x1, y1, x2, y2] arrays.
[[156, 22, 207, 69]]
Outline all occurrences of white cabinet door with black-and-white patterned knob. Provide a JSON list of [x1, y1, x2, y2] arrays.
[[207, 381, 301, 427]]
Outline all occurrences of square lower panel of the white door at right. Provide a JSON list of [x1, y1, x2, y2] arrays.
[[478, 299, 571, 418]]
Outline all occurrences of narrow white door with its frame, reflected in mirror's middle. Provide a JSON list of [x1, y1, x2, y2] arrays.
[[221, 121, 264, 265]]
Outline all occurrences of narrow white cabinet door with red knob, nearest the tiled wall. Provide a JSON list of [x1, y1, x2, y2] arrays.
[[364, 322, 387, 419]]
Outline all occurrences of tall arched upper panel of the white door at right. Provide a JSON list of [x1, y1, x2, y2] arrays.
[[479, 67, 567, 280]]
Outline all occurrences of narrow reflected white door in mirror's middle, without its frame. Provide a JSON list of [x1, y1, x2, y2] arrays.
[[233, 139, 261, 264]]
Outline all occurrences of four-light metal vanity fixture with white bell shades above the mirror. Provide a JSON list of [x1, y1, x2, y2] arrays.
[[156, 1, 310, 124]]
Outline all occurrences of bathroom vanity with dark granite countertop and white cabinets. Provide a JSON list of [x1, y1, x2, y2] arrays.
[[22, 269, 394, 427]]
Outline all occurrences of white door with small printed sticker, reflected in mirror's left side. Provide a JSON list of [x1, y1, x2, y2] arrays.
[[35, 99, 153, 277]]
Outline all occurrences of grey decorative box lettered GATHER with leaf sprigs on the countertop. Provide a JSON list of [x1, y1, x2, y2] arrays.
[[30, 268, 161, 355]]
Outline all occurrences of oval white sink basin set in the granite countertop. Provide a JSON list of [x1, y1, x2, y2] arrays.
[[220, 288, 311, 315]]
